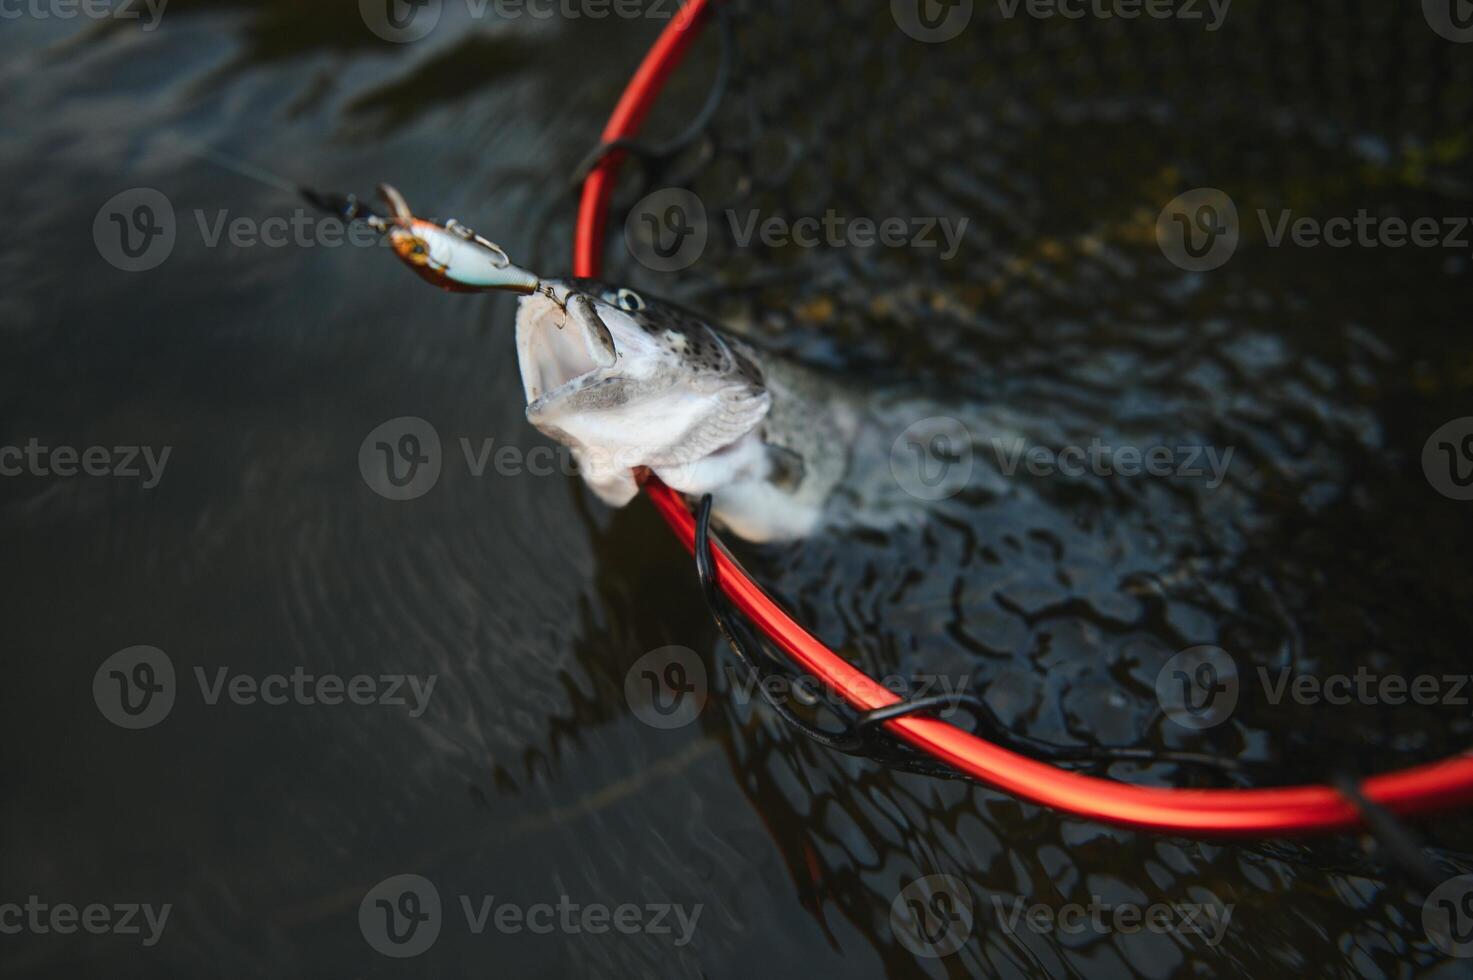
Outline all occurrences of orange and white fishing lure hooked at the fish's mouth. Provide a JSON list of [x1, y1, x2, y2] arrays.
[[302, 184, 542, 293]]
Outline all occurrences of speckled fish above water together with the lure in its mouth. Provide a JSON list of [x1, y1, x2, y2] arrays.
[[303, 184, 863, 544]]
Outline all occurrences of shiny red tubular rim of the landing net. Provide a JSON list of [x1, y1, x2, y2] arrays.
[[573, 0, 1473, 837]]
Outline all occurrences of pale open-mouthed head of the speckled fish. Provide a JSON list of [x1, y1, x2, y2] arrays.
[[517, 280, 772, 486]]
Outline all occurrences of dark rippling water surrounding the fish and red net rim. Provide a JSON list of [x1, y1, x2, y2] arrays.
[[0, 0, 1473, 977]]
